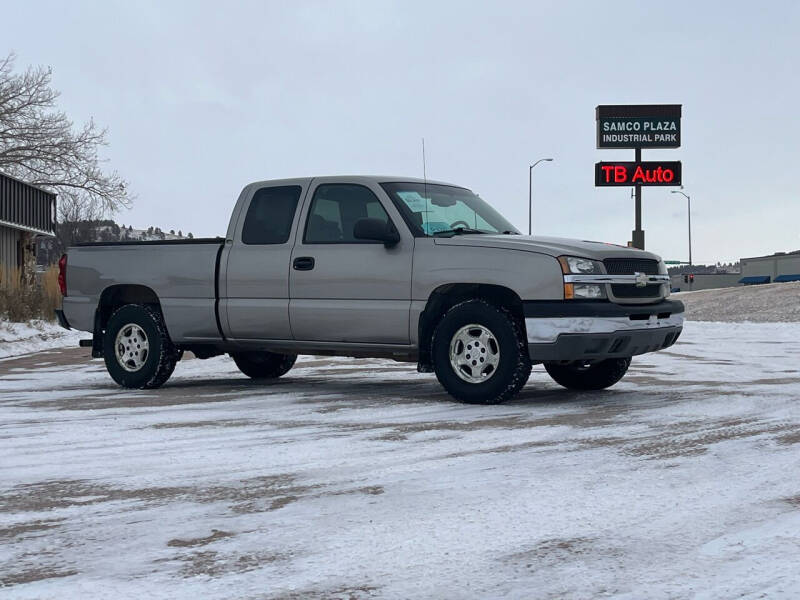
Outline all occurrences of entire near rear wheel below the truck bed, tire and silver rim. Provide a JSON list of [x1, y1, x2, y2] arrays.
[[103, 304, 178, 389]]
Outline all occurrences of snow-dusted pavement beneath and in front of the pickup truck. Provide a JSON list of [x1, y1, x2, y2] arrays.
[[0, 323, 800, 600]]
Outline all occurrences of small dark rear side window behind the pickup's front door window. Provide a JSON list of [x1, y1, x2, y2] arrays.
[[242, 185, 303, 244]]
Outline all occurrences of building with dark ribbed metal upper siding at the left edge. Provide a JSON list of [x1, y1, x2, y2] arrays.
[[0, 173, 56, 270]]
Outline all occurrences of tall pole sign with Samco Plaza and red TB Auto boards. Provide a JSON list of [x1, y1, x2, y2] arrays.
[[594, 104, 682, 250]]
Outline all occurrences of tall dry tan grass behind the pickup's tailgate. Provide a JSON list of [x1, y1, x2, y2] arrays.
[[0, 266, 61, 322]]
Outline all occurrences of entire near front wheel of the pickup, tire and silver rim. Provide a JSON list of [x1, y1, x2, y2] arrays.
[[431, 300, 531, 404]]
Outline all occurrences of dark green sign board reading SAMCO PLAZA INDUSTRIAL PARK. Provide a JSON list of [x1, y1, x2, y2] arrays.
[[595, 104, 681, 148]]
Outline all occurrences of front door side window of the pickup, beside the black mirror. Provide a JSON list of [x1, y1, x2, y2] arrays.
[[303, 183, 389, 244]]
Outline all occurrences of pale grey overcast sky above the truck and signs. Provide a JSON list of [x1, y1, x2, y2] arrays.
[[0, 0, 800, 263]]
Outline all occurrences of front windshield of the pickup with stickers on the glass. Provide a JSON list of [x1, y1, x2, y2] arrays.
[[381, 183, 519, 236]]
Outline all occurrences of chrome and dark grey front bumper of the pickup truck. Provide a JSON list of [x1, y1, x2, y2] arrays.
[[524, 300, 684, 362]]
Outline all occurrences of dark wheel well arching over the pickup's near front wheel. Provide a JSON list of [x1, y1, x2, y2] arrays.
[[419, 283, 525, 371]]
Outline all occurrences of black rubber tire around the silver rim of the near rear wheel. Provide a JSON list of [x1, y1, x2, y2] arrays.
[[103, 304, 178, 389]]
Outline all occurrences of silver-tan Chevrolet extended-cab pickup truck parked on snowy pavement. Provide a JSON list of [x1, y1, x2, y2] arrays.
[[57, 177, 683, 404]]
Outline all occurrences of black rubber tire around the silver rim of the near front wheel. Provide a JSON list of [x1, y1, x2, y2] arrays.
[[431, 300, 531, 404]]
